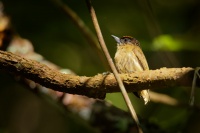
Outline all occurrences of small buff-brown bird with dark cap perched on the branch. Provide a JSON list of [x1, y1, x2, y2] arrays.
[[112, 35, 150, 104]]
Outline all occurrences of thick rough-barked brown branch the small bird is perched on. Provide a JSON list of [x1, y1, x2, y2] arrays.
[[0, 51, 194, 99]]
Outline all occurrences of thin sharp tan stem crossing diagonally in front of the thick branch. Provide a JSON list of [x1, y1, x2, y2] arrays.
[[86, 0, 143, 133]]
